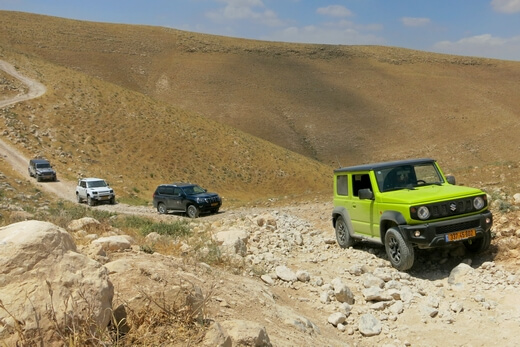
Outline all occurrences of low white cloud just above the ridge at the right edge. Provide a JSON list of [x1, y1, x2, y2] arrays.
[[434, 34, 520, 60]]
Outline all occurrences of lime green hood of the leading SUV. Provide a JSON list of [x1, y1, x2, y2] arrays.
[[381, 183, 484, 205]]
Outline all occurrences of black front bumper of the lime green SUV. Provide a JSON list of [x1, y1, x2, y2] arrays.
[[399, 211, 493, 248]]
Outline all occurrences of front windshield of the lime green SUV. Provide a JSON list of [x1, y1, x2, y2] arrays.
[[375, 163, 444, 192]]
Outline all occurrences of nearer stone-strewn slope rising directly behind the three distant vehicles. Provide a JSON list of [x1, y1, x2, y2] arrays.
[[0, 53, 331, 204]]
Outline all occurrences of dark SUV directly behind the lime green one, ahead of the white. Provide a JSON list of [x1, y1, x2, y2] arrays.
[[153, 183, 222, 218]]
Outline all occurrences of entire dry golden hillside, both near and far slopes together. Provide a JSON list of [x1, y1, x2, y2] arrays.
[[0, 11, 520, 198]]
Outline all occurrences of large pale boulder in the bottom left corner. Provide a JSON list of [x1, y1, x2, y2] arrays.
[[0, 220, 114, 345]]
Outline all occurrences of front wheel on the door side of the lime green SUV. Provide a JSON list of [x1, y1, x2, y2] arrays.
[[385, 228, 415, 271]]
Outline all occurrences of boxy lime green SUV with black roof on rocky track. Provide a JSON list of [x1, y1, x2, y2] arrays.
[[332, 159, 493, 271]]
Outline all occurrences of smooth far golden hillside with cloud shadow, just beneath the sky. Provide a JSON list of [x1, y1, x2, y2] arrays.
[[0, 12, 520, 174]]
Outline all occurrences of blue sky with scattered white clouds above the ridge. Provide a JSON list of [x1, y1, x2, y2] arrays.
[[0, 0, 520, 61]]
